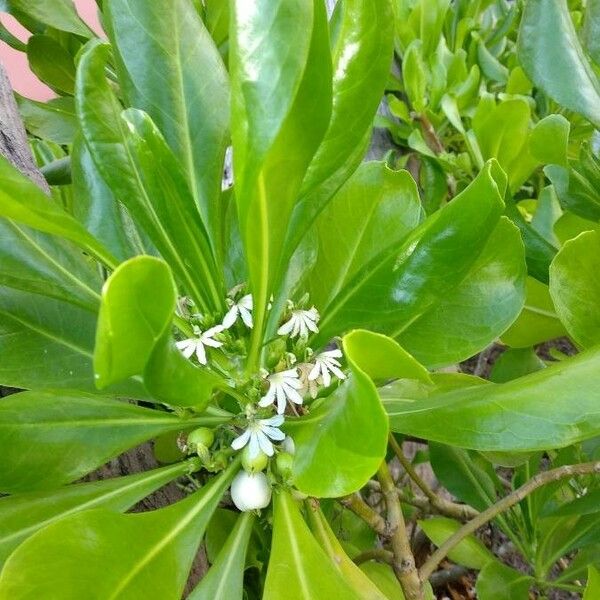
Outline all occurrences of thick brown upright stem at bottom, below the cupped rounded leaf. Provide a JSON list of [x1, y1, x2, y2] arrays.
[[377, 460, 423, 600]]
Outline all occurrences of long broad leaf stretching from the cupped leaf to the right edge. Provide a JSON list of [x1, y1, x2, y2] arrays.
[[381, 348, 600, 452]]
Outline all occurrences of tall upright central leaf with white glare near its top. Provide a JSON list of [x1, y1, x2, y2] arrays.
[[229, 0, 331, 352]]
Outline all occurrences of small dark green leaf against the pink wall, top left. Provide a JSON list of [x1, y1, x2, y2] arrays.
[[27, 35, 75, 94]]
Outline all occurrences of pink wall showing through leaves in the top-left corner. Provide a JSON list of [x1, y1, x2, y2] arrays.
[[0, 0, 102, 100]]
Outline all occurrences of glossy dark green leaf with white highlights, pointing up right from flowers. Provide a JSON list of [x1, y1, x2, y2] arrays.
[[317, 163, 503, 358]]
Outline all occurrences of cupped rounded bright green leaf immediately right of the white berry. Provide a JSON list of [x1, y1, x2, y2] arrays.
[[286, 338, 388, 498]]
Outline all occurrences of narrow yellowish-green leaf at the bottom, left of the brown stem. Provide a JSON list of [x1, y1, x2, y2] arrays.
[[306, 502, 386, 600]]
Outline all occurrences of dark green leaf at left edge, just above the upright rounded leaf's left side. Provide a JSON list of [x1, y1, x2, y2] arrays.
[[0, 219, 102, 312]]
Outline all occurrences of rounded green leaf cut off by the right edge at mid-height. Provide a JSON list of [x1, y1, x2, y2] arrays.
[[550, 231, 600, 348]]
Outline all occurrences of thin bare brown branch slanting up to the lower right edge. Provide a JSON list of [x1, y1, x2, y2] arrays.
[[419, 461, 600, 581]]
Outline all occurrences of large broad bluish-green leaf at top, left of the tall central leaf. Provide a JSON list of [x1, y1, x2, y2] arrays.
[[107, 0, 229, 245]]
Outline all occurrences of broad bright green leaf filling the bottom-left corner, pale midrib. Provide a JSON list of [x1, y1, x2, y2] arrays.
[[0, 463, 237, 600]]
